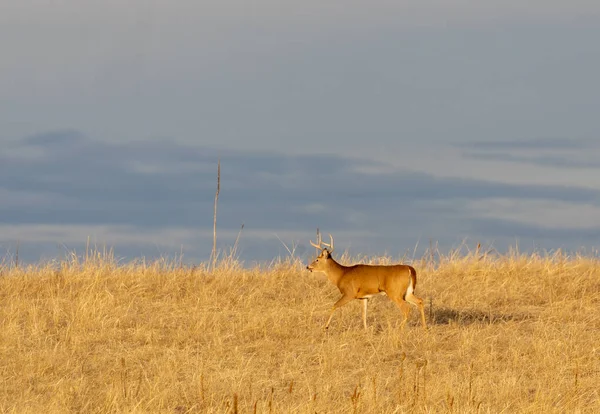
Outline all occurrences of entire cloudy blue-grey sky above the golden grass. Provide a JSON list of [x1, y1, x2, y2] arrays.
[[0, 0, 600, 263]]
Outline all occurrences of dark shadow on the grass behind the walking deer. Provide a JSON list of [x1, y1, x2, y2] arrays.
[[427, 307, 533, 325]]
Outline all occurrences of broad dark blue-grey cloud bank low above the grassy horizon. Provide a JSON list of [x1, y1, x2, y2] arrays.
[[0, 131, 600, 259]]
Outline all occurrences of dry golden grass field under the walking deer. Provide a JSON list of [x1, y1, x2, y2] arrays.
[[0, 247, 600, 414]]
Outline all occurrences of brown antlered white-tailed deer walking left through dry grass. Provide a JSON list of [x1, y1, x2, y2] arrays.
[[306, 234, 427, 329]]
